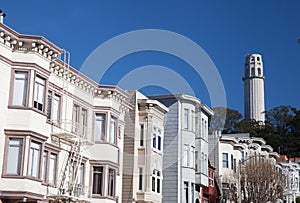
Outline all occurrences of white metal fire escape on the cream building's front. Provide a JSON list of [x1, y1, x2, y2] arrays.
[[47, 50, 92, 202]]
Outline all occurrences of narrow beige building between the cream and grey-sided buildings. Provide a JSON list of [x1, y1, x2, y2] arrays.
[[122, 91, 168, 203]]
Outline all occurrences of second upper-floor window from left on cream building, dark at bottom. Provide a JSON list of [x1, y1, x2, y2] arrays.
[[33, 76, 46, 111]]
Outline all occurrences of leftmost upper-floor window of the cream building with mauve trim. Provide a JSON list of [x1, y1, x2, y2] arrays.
[[12, 71, 28, 106]]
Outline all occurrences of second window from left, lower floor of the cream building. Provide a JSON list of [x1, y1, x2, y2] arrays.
[[28, 142, 41, 178]]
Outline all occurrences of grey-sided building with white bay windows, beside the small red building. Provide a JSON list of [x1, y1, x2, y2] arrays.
[[150, 94, 213, 203]]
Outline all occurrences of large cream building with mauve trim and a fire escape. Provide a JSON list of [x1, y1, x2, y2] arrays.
[[0, 19, 130, 203]]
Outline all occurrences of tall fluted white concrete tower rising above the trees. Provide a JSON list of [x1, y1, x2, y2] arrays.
[[243, 54, 265, 122]]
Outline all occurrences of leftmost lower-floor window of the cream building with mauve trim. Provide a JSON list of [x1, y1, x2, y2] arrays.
[[6, 138, 23, 175]]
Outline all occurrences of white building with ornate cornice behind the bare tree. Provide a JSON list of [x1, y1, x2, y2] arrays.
[[208, 131, 279, 202]]
